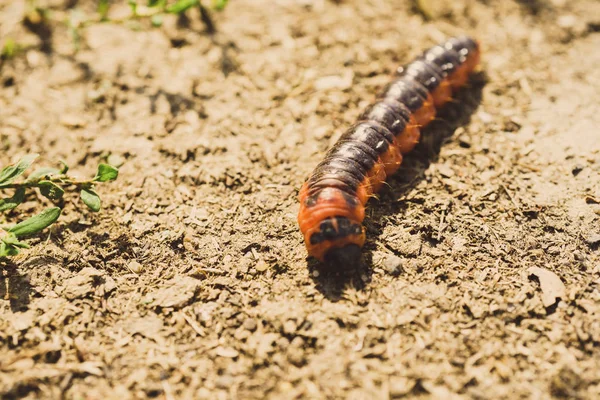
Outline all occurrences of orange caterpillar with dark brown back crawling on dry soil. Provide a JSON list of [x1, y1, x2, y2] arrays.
[[298, 36, 480, 264]]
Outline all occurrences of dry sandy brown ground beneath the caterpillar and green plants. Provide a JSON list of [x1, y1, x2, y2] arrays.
[[0, 0, 600, 400]]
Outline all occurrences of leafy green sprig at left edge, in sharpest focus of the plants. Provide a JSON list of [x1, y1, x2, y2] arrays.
[[0, 154, 119, 258]]
